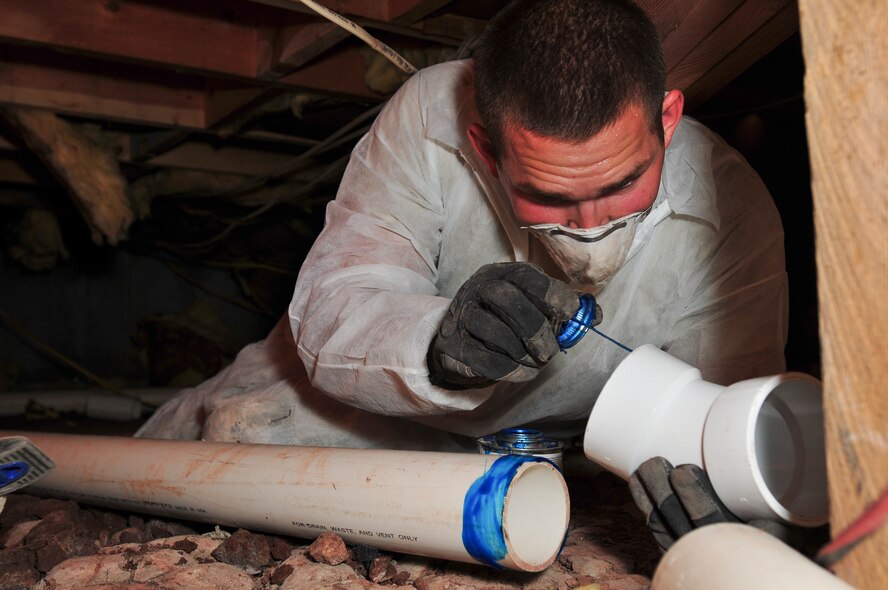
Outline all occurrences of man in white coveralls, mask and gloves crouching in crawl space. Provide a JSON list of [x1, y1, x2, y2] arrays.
[[139, 0, 786, 544]]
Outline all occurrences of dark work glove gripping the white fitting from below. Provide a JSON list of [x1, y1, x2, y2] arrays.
[[629, 457, 829, 557]]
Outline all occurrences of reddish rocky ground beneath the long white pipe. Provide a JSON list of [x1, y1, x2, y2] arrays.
[[0, 473, 660, 590]]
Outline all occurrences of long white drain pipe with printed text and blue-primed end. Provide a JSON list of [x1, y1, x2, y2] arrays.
[[0, 433, 570, 571]]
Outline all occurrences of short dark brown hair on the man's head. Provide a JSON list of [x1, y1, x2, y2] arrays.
[[474, 0, 666, 153]]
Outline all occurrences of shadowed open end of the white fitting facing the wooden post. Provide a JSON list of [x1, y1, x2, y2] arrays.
[[755, 378, 828, 525]]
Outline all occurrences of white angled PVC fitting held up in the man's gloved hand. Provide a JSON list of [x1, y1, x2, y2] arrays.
[[583, 345, 829, 526]]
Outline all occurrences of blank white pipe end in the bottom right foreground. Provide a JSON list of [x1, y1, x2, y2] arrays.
[[651, 523, 852, 590]]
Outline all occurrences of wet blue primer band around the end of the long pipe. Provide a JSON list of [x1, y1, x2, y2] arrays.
[[463, 455, 552, 569]]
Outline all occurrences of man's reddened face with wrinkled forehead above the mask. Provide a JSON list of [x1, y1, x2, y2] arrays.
[[470, 93, 682, 228]]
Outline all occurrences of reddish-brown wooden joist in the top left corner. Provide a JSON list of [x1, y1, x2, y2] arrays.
[[0, 0, 257, 77]]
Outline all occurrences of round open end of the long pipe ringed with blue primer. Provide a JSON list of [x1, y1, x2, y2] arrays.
[[503, 463, 570, 571]]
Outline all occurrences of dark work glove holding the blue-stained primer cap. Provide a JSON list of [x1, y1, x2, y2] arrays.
[[428, 262, 580, 389]]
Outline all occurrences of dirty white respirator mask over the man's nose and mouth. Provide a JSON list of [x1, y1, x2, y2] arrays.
[[521, 208, 650, 289]]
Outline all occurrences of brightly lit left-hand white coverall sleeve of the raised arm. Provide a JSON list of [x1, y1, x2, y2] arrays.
[[289, 72, 492, 416]]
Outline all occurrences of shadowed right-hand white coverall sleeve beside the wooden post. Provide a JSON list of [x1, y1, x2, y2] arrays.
[[663, 145, 788, 385]]
